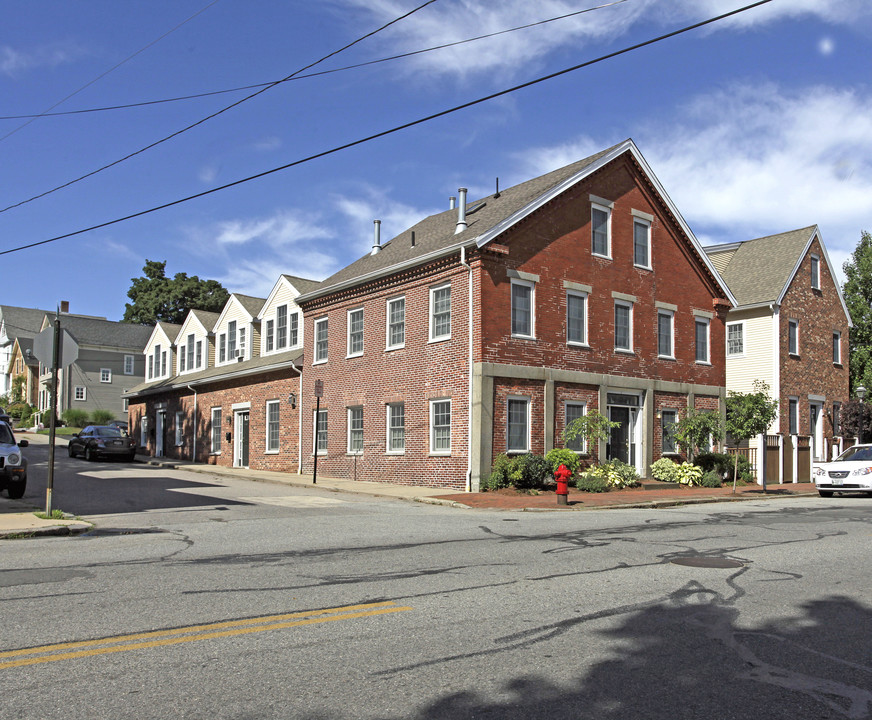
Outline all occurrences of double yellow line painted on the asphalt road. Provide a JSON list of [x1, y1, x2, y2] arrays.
[[0, 602, 412, 670]]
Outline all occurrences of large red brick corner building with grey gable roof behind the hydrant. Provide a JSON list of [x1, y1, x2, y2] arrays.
[[297, 140, 735, 490]]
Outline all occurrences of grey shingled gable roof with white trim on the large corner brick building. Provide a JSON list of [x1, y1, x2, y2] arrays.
[[297, 140, 735, 304]]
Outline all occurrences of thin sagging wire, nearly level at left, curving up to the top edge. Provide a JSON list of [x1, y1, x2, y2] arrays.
[[0, 0, 628, 120]]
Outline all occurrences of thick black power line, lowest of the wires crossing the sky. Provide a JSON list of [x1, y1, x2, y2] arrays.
[[0, 0, 772, 255]]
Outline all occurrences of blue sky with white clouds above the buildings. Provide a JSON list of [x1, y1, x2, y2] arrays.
[[0, 0, 872, 320]]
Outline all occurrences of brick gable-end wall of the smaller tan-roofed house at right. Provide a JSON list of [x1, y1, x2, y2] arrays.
[[778, 238, 848, 438]]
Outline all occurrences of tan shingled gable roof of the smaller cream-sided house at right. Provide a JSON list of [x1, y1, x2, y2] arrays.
[[705, 225, 853, 327]]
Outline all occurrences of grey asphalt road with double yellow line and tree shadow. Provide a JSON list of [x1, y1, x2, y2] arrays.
[[0, 436, 872, 720]]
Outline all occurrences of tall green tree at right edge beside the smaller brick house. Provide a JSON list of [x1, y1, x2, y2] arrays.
[[842, 230, 872, 388]]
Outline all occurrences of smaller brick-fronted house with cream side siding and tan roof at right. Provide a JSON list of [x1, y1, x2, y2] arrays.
[[705, 226, 852, 482]]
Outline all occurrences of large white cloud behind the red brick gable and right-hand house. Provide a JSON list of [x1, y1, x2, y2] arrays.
[[518, 85, 872, 286]]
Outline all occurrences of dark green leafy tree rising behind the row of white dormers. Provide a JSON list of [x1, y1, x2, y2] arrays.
[[122, 260, 230, 325]]
